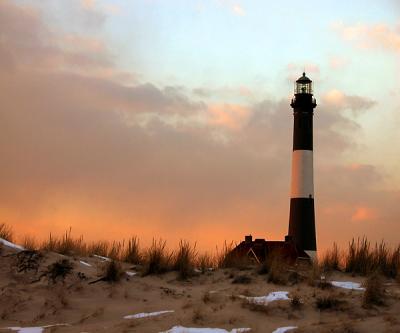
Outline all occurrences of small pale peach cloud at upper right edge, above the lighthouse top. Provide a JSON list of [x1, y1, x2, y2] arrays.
[[333, 22, 400, 52]]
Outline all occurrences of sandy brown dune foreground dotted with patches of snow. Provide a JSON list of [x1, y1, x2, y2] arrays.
[[0, 243, 400, 333]]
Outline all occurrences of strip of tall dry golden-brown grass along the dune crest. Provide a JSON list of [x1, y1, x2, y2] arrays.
[[0, 223, 400, 278]]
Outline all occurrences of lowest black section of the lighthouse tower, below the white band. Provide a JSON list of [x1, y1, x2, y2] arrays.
[[289, 198, 317, 251]]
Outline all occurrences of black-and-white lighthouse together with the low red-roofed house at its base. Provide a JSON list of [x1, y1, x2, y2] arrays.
[[230, 73, 317, 263]]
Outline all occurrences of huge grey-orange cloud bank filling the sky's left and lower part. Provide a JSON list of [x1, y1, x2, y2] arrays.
[[0, 1, 400, 249]]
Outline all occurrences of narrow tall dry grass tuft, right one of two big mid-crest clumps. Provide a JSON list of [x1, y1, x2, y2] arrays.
[[173, 241, 197, 280]]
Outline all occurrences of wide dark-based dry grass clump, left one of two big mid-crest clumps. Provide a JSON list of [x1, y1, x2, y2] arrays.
[[143, 239, 172, 275]]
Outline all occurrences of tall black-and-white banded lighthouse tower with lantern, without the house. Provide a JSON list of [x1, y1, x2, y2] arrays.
[[288, 73, 317, 259]]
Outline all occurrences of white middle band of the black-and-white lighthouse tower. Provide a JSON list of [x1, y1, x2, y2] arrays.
[[291, 150, 314, 198]]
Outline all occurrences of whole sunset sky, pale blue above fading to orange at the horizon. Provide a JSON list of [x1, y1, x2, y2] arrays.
[[0, 0, 400, 250]]
